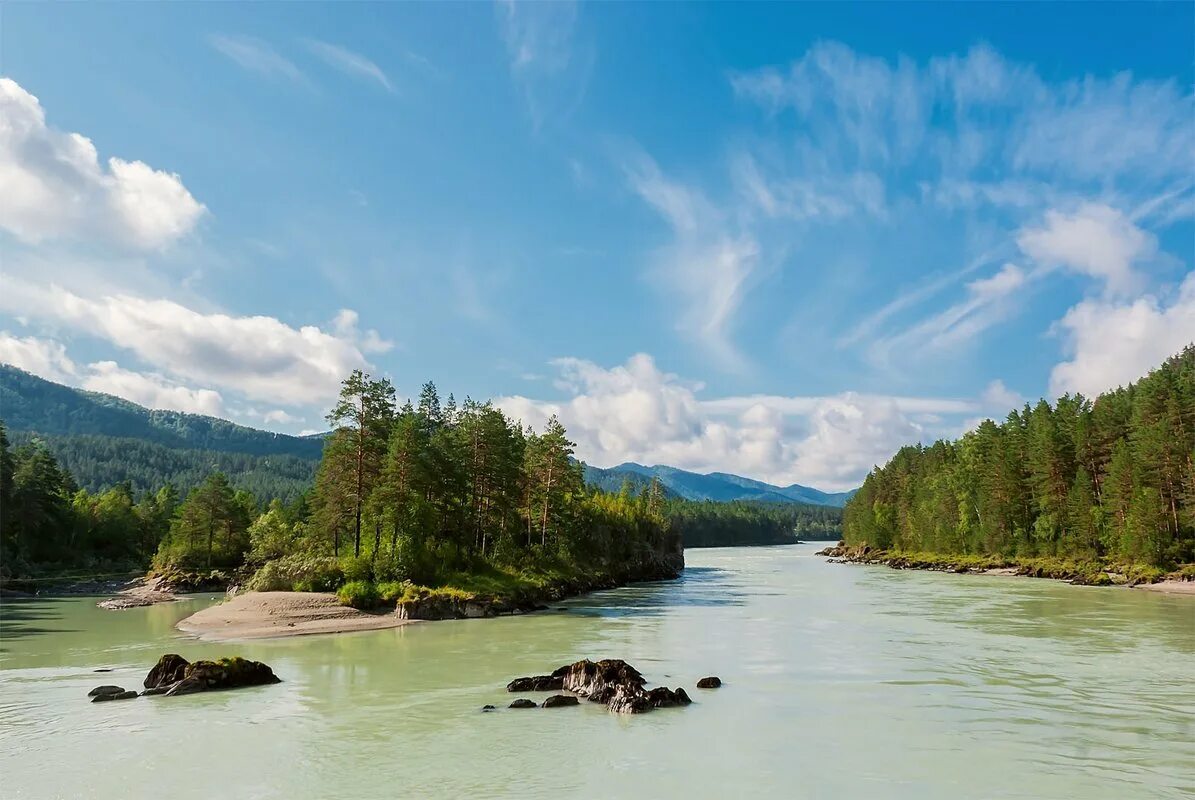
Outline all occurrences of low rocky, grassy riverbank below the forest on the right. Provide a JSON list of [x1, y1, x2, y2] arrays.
[[816, 542, 1195, 597]]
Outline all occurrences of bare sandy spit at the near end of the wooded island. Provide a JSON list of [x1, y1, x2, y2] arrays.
[[176, 592, 411, 641]]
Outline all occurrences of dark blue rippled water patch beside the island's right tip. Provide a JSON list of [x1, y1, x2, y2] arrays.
[[566, 567, 747, 617]]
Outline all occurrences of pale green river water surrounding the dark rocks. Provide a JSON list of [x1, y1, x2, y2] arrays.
[[0, 545, 1195, 800]]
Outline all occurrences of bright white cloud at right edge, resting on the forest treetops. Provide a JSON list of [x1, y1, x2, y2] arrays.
[[1049, 273, 1195, 397]]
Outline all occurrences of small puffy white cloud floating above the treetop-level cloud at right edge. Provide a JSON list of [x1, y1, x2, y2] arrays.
[[1017, 203, 1158, 295]]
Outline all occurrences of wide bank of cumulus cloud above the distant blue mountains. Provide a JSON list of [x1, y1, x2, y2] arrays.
[[496, 353, 999, 490]]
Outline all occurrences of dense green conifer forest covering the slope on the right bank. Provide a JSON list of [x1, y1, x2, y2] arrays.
[[844, 346, 1195, 568]]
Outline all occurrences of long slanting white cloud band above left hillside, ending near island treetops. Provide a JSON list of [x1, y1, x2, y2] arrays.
[[0, 280, 391, 405]]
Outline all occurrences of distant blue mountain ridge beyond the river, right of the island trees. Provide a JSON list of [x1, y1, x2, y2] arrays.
[[586, 462, 854, 508]]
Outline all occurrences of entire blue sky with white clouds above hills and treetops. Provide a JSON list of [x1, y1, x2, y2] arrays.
[[0, 2, 1195, 490]]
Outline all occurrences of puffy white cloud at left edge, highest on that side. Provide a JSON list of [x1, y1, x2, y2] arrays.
[[0, 78, 206, 250]]
